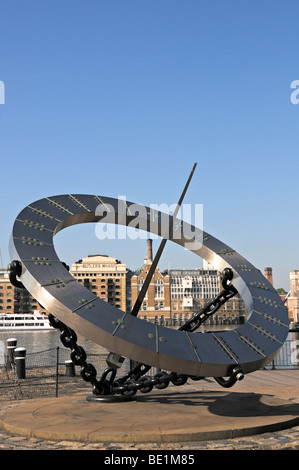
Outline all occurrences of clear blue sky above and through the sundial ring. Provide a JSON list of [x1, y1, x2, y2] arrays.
[[0, 0, 299, 290]]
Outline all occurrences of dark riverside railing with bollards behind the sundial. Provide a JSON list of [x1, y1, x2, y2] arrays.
[[0, 338, 299, 400]]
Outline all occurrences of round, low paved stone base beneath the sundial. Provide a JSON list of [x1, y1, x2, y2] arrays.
[[0, 390, 299, 442]]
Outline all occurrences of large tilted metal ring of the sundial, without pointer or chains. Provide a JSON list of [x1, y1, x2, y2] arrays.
[[10, 194, 288, 377]]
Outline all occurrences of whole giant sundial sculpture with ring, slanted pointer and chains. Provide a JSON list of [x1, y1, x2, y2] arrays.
[[9, 166, 289, 400]]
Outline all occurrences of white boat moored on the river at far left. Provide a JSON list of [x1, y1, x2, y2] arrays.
[[0, 311, 53, 331]]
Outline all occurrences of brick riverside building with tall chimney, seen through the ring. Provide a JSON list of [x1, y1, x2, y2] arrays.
[[131, 240, 246, 324]]
